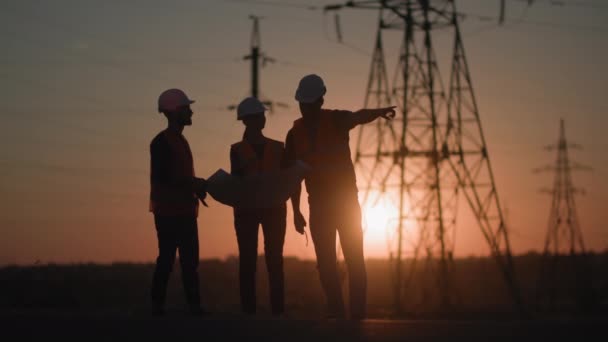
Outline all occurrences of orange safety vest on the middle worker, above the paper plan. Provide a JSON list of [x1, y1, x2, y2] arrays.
[[231, 138, 284, 176]]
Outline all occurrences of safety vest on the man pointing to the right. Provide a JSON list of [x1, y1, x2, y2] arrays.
[[292, 110, 356, 197]]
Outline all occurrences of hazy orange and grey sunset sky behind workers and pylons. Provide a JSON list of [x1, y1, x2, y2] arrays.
[[0, 0, 608, 265]]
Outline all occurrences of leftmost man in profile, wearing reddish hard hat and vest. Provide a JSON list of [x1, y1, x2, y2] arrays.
[[150, 89, 206, 315]]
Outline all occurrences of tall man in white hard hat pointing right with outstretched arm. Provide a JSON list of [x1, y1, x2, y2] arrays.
[[285, 74, 395, 319]]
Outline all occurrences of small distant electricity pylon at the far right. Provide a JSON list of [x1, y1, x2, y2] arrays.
[[535, 119, 594, 311]]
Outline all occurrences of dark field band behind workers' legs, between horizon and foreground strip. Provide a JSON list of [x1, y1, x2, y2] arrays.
[[0, 253, 608, 319]]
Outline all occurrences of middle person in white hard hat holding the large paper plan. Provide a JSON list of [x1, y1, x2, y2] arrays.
[[230, 97, 286, 315]]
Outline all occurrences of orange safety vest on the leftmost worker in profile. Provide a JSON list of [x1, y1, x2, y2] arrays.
[[150, 130, 198, 217]]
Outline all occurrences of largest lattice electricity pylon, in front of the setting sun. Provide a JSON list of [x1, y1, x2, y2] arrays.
[[326, 0, 523, 312]]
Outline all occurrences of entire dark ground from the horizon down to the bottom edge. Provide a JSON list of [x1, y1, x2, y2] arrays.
[[0, 253, 608, 342]]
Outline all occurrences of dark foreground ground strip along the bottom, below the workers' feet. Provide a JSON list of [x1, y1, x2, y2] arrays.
[[0, 311, 608, 342]]
